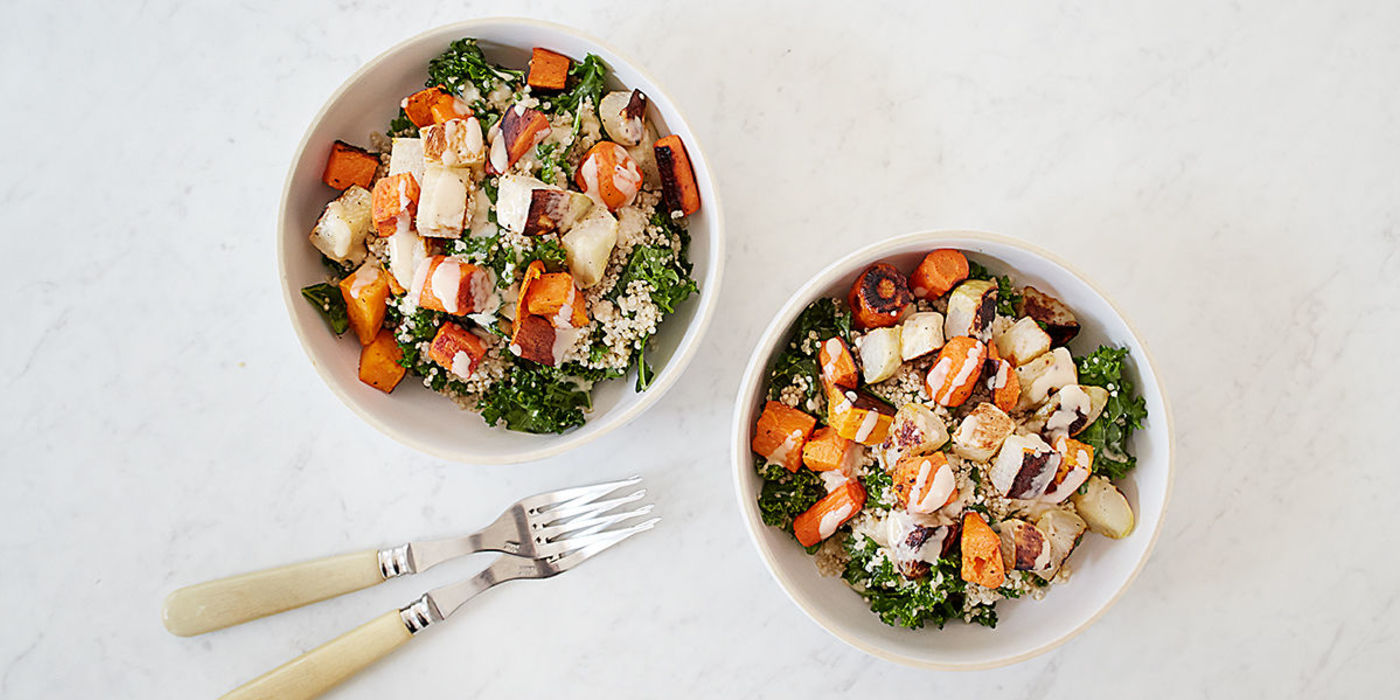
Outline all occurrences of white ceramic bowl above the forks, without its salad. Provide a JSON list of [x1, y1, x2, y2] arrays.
[[277, 18, 724, 463]]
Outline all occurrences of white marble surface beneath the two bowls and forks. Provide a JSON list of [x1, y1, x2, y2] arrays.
[[0, 0, 1400, 699]]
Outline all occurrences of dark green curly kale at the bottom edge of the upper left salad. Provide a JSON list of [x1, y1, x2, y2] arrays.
[[476, 360, 594, 433]]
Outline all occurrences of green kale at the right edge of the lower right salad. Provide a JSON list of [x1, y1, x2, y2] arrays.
[[1075, 346, 1147, 480]]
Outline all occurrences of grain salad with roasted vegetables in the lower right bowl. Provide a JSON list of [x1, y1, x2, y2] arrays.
[[750, 249, 1147, 627]]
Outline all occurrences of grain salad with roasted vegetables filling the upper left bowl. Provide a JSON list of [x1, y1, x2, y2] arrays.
[[302, 38, 700, 433]]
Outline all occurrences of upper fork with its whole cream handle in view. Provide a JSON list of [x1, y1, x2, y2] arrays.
[[161, 476, 655, 638]]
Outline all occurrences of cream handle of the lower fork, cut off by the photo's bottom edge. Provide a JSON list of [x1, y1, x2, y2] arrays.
[[215, 610, 413, 700]]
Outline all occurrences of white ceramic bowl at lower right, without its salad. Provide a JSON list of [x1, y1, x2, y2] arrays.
[[731, 231, 1172, 671]]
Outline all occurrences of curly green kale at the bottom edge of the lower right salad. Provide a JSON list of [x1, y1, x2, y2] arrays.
[[841, 536, 997, 629]]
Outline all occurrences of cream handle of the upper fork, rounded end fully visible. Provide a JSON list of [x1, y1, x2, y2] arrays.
[[161, 549, 384, 637]]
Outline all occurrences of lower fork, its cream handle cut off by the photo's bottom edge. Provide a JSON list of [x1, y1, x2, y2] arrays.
[[224, 518, 659, 700]]
